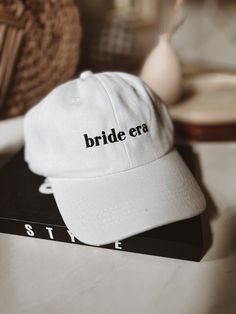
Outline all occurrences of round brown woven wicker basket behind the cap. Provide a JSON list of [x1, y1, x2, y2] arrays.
[[0, 0, 81, 119]]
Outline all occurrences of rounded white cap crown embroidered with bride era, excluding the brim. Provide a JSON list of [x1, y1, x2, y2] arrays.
[[24, 72, 173, 178]]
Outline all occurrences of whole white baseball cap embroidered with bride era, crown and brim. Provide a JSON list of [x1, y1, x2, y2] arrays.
[[24, 71, 205, 245]]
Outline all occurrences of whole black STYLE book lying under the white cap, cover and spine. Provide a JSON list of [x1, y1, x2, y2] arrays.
[[0, 151, 203, 261]]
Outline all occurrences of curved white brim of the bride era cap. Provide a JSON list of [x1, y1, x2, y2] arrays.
[[50, 150, 205, 245]]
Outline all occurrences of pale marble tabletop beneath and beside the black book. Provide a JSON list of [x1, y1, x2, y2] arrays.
[[0, 143, 236, 314]]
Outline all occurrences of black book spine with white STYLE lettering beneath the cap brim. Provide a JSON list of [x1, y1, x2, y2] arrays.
[[0, 218, 201, 261]]
